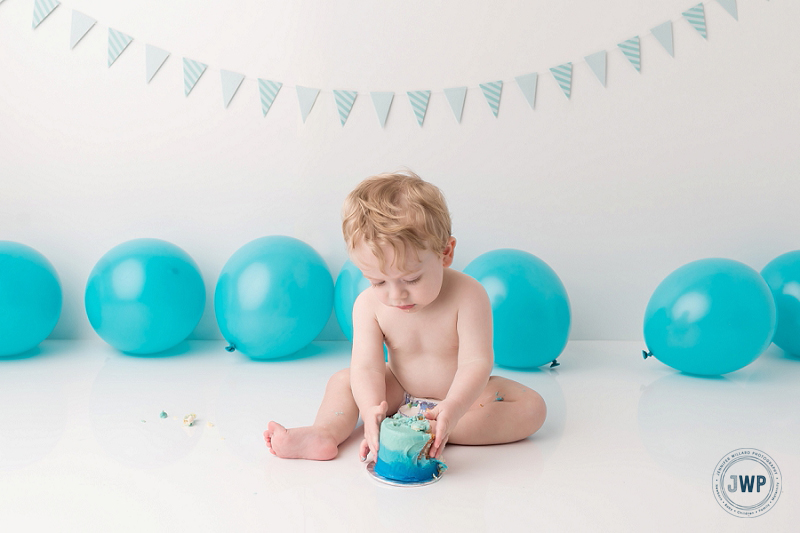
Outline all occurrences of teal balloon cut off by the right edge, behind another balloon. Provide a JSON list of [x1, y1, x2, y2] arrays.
[[761, 250, 800, 355]]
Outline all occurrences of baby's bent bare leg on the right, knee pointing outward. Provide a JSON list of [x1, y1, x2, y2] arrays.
[[449, 376, 547, 444]]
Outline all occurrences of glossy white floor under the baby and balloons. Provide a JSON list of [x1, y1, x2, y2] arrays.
[[0, 341, 800, 532]]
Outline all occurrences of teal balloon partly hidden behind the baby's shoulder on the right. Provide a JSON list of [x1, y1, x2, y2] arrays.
[[464, 249, 570, 369]]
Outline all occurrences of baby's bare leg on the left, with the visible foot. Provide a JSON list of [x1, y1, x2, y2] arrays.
[[264, 365, 403, 461]]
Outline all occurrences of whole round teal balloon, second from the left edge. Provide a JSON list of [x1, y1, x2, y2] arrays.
[[84, 239, 206, 354]]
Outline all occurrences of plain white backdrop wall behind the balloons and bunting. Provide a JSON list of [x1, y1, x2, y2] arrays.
[[0, 0, 800, 340]]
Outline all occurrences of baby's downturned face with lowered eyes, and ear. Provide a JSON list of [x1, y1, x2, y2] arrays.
[[350, 237, 456, 313]]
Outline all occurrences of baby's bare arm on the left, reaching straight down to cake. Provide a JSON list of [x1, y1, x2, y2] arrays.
[[350, 289, 388, 460]]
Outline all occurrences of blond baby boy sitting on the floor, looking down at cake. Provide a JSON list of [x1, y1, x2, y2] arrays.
[[264, 172, 547, 460]]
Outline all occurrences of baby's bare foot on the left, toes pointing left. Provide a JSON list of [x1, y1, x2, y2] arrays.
[[264, 422, 339, 461]]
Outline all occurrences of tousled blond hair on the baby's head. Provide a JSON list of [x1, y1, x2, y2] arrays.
[[342, 171, 451, 271]]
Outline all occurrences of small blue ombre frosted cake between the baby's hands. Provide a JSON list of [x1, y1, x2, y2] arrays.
[[375, 413, 447, 483]]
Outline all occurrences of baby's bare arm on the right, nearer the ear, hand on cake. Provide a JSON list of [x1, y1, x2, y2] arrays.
[[425, 282, 494, 457]]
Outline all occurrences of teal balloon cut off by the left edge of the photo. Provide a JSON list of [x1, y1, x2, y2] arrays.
[[0, 241, 62, 356]]
